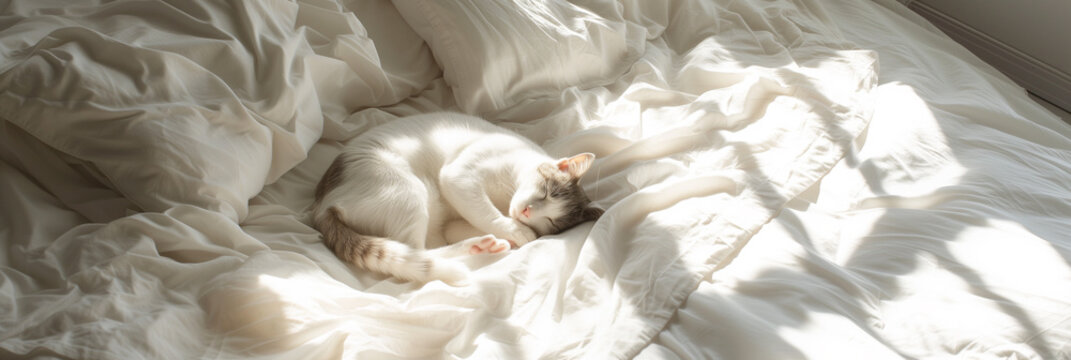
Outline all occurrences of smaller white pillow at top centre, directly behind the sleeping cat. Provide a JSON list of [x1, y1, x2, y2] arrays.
[[394, 0, 646, 115]]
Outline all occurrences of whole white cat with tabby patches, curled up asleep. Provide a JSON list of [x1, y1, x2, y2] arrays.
[[312, 113, 602, 285]]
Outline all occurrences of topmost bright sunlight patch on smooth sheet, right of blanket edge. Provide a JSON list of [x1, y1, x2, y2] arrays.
[[815, 81, 968, 211]]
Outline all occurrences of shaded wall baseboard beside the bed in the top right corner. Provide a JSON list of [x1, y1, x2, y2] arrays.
[[901, 0, 1071, 111]]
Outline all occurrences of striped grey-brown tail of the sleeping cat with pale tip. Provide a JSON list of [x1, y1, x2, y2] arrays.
[[314, 207, 469, 286]]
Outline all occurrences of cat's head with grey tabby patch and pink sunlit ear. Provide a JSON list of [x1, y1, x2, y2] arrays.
[[510, 153, 603, 236]]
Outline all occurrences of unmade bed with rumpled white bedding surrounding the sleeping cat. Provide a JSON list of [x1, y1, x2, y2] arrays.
[[0, 0, 1071, 359]]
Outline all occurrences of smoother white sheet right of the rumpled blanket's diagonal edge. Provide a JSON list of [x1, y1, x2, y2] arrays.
[[643, 1, 1071, 359]]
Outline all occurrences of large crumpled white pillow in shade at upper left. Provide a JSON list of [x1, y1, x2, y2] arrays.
[[0, 1, 426, 221]]
